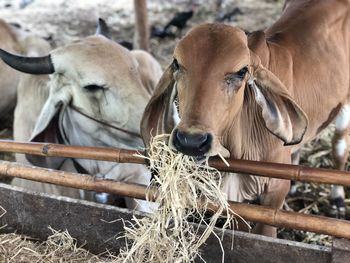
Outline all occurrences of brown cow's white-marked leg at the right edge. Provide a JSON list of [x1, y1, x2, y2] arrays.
[[330, 104, 350, 218]]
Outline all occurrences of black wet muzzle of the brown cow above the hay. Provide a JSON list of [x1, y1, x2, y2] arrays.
[[173, 129, 213, 156]]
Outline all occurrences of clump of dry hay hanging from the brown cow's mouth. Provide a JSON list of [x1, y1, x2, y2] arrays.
[[115, 135, 243, 263]]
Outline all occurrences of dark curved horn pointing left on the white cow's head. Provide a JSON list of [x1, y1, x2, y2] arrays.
[[0, 49, 55, 75]]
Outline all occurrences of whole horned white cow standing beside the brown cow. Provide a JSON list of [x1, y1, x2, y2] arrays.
[[0, 20, 162, 211]]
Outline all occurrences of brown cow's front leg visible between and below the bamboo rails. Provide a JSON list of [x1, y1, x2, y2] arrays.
[[253, 178, 290, 237]]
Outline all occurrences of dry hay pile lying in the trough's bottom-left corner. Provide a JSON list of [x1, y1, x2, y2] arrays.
[[0, 228, 113, 263]]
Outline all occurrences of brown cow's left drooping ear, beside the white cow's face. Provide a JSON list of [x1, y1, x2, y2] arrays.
[[141, 66, 176, 147]]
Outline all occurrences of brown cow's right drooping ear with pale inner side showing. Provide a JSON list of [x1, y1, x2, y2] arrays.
[[248, 64, 308, 145]]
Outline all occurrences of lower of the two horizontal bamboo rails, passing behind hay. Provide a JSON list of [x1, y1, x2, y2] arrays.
[[0, 161, 350, 239]]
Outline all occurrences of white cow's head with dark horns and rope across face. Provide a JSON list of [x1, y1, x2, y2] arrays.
[[0, 20, 161, 172]]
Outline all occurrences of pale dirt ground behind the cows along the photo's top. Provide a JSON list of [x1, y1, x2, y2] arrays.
[[0, 0, 283, 66]]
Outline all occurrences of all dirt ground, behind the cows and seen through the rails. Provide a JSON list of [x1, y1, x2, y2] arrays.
[[0, 0, 350, 248]]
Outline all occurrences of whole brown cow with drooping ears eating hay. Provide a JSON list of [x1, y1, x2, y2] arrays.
[[141, 0, 350, 236]]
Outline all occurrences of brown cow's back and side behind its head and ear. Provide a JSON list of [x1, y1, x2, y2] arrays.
[[265, 0, 350, 144]]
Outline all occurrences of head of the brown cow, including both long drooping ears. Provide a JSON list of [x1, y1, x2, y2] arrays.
[[142, 24, 307, 159]]
